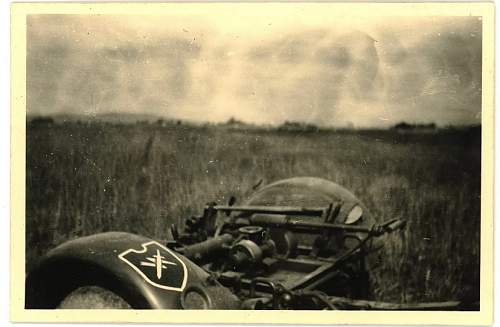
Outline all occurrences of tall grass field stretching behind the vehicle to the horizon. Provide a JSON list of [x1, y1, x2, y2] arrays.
[[26, 123, 481, 302]]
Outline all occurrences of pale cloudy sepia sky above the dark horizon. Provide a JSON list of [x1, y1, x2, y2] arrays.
[[27, 12, 481, 127]]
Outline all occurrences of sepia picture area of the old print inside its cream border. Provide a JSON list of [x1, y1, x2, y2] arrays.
[[15, 4, 492, 320]]
